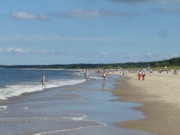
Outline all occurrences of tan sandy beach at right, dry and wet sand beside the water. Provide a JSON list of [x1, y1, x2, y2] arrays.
[[113, 72, 180, 135]]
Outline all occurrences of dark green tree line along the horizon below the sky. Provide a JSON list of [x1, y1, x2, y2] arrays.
[[0, 57, 180, 69]]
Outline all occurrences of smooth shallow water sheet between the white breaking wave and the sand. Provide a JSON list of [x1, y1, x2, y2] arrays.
[[0, 71, 155, 135]]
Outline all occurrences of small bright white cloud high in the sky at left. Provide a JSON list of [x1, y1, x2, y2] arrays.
[[11, 11, 50, 21]]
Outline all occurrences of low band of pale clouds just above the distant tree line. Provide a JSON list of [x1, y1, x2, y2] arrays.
[[0, 48, 180, 64]]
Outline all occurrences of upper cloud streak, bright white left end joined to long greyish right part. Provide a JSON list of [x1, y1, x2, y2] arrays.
[[10, 9, 139, 21]]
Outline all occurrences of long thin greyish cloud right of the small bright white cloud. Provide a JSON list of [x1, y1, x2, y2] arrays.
[[52, 9, 138, 18]]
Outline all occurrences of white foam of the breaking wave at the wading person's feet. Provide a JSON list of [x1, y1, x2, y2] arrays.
[[0, 79, 85, 100]]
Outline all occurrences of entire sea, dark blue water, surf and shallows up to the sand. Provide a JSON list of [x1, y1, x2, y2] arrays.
[[0, 69, 154, 135]]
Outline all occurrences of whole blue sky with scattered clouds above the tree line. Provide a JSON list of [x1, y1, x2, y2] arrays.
[[0, 0, 180, 65]]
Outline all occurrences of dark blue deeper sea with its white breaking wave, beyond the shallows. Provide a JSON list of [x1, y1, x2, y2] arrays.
[[0, 69, 93, 100]]
